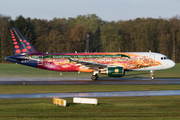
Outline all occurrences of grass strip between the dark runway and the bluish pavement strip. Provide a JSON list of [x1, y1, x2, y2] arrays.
[[0, 85, 180, 94]]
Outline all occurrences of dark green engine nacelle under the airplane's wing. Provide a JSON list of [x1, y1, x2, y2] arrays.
[[101, 67, 124, 77]]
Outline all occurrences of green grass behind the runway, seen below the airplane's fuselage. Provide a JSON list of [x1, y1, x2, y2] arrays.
[[0, 63, 180, 78]]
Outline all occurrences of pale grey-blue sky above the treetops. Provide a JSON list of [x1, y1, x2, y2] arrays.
[[0, 0, 180, 21]]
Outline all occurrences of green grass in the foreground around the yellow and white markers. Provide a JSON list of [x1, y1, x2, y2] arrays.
[[0, 96, 180, 120]]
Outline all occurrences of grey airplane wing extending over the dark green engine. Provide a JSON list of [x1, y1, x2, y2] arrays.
[[69, 59, 107, 69]]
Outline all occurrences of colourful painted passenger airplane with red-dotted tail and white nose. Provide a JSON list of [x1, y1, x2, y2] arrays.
[[5, 27, 175, 80]]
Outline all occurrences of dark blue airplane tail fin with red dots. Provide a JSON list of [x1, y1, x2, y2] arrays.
[[9, 27, 40, 55]]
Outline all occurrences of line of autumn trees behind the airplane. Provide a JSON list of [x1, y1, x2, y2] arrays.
[[0, 14, 180, 62]]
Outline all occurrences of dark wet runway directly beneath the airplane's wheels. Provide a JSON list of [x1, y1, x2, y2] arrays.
[[0, 78, 180, 85]]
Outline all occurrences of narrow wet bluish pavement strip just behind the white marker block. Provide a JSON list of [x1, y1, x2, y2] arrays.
[[0, 90, 180, 99]]
